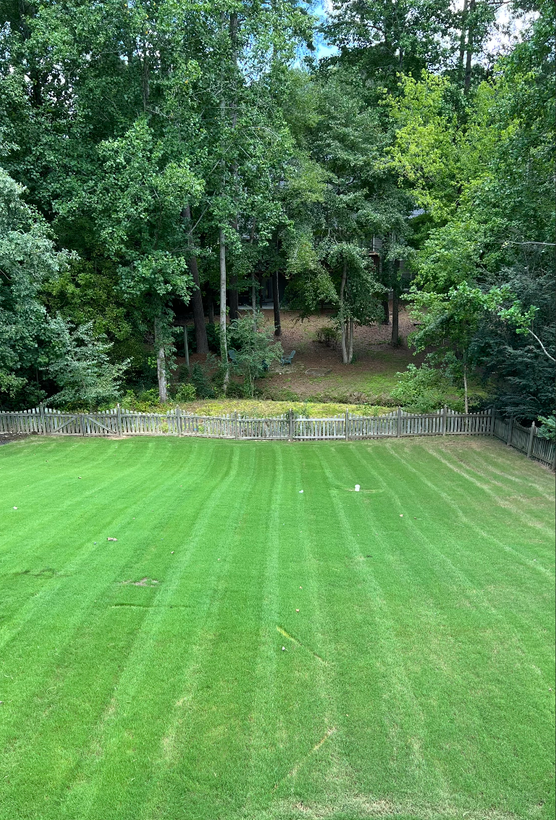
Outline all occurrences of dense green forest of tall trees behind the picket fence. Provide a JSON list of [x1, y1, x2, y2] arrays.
[[0, 0, 556, 421]]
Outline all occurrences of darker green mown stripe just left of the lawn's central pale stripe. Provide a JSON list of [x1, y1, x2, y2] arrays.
[[132, 445, 274, 817]]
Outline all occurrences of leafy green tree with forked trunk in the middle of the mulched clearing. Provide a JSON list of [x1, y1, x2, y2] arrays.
[[286, 68, 409, 364]]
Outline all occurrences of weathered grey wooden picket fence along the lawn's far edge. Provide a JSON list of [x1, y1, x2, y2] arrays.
[[0, 405, 556, 469]]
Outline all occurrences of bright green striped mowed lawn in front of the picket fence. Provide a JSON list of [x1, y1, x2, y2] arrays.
[[0, 438, 554, 820]]
